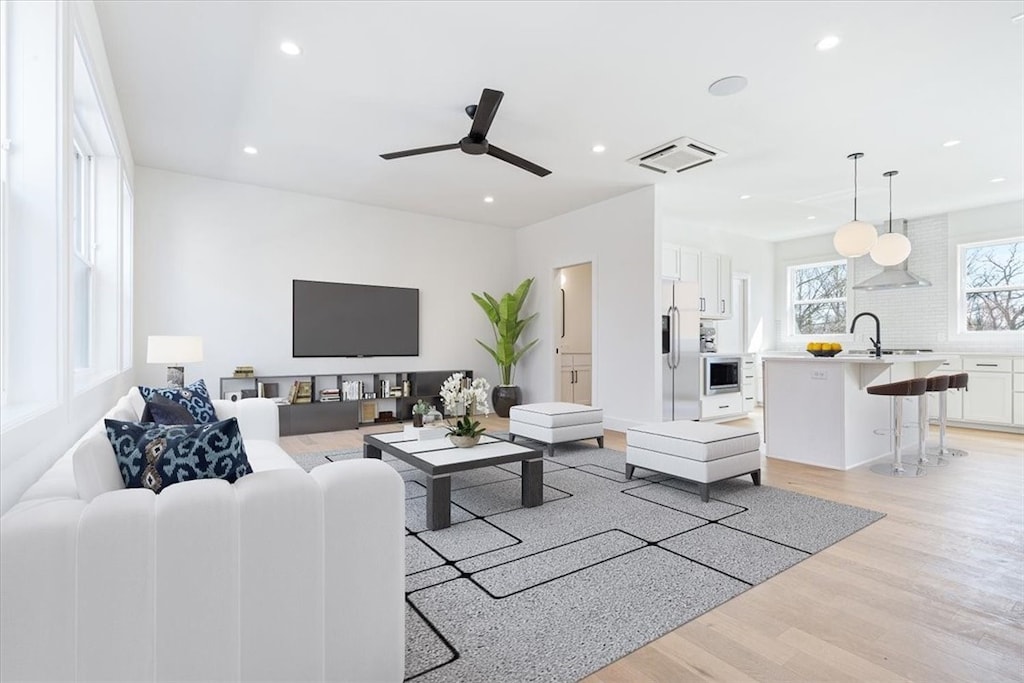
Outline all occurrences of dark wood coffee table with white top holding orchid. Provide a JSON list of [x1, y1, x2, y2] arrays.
[[362, 432, 544, 529]]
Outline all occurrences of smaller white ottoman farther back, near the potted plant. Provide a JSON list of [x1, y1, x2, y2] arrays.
[[509, 402, 604, 458]]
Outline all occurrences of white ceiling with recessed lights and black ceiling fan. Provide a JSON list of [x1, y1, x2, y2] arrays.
[[96, 0, 1024, 240]]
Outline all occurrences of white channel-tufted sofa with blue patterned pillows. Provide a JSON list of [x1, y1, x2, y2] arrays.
[[0, 388, 406, 681]]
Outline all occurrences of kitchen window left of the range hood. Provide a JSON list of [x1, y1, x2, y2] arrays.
[[787, 260, 846, 335]]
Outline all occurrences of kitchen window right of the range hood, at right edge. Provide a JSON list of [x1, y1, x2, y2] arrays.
[[959, 240, 1024, 332]]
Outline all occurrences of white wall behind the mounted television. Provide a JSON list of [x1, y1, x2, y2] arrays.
[[135, 167, 513, 392]]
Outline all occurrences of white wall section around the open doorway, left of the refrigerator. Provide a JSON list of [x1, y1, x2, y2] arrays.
[[515, 187, 662, 429]]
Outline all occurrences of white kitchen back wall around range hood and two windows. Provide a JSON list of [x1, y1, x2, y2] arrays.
[[775, 202, 1024, 354]]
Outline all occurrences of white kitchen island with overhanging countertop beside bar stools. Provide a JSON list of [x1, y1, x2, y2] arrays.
[[762, 353, 946, 470]]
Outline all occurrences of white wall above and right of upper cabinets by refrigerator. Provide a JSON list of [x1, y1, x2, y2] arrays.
[[662, 214, 776, 353]]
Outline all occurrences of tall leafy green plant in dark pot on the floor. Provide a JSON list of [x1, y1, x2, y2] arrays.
[[473, 278, 539, 418]]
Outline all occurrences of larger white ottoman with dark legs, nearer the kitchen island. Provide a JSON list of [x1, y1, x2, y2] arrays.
[[626, 420, 761, 503]]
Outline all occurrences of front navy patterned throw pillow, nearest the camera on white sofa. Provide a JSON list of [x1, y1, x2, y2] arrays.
[[104, 418, 253, 494]]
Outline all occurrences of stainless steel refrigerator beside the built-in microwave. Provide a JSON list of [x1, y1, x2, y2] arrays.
[[662, 280, 700, 422]]
